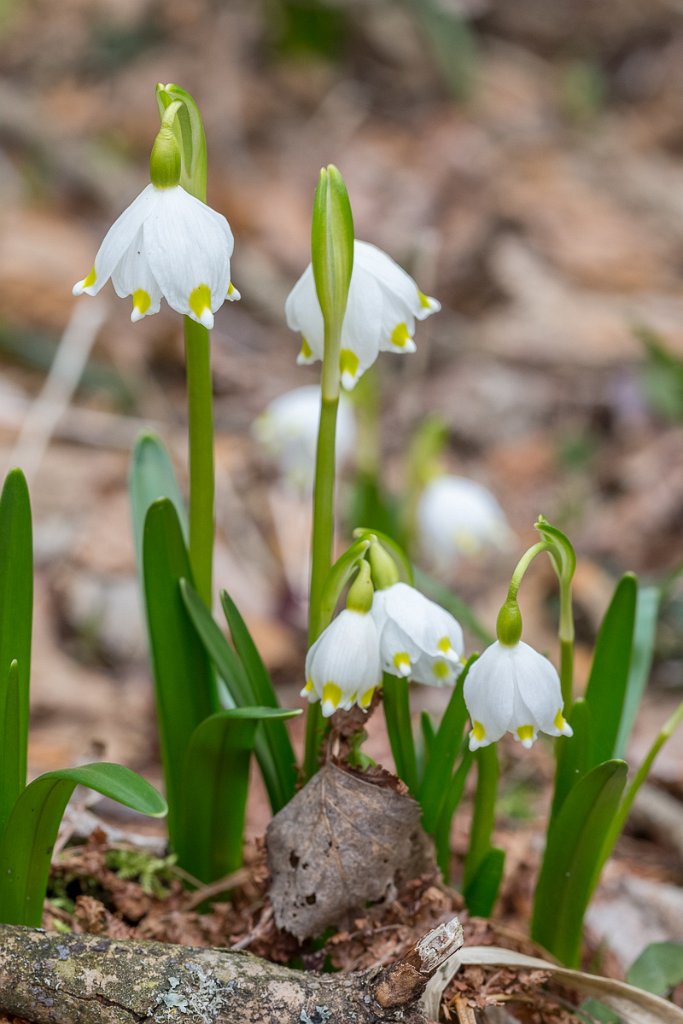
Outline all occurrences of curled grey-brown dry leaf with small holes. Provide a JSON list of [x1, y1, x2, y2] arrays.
[[266, 764, 434, 941]]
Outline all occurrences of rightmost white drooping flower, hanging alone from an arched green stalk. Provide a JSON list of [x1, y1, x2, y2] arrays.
[[464, 640, 571, 751]]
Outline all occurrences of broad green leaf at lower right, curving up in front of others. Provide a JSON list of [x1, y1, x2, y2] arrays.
[[531, 761, 628, 967]]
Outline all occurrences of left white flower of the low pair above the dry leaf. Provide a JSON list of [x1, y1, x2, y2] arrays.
[[301, 608, 382, 718]]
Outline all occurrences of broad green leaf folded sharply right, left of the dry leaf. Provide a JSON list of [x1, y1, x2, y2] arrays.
[[179, 708, 301, 883]]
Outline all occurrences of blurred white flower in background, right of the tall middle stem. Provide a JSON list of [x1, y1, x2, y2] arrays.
[[417, 475, 514, 566]]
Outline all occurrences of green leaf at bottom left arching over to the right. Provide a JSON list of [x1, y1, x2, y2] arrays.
[[0, 764, 166, 928]]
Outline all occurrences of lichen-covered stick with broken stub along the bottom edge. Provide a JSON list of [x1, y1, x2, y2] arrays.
[[0, 921, 462, 1024]]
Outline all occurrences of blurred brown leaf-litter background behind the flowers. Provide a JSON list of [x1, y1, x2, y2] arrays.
[[0, 0, 683, 913]]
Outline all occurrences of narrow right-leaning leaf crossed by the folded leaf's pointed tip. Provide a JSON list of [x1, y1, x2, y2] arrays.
[[181, 580, 297, 814]]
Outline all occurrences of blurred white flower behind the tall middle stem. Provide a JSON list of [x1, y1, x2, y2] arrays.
[[252, 384, 355, 493]]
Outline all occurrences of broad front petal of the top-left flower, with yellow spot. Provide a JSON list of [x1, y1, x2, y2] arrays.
[[144, 186, 234, 327]]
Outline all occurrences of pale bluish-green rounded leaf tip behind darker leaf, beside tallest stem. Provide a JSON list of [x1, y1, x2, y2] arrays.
[[128, 430, 187, 566]]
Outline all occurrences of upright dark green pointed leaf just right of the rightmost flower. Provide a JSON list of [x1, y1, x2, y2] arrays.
[[586, 572, 638, 764]]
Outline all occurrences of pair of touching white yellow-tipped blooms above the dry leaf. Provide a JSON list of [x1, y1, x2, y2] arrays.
[[301, 583, 464, 717]]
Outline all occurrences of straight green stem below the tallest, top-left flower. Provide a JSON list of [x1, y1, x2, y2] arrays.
[[185, 316, 214, 608]]
